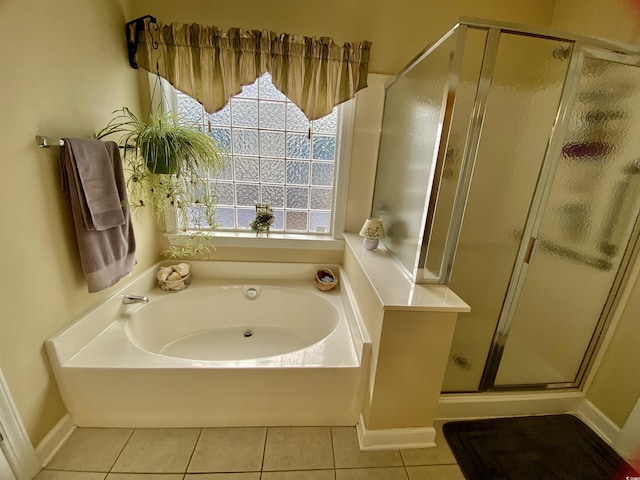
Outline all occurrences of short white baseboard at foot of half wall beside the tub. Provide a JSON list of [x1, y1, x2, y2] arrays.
[[356, 414, 436, 451]]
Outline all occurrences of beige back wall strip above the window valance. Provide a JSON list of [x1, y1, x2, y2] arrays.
[[133, 0, 554, 75]]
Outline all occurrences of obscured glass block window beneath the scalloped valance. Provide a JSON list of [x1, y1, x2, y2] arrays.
[[174, 73, 339, 235]]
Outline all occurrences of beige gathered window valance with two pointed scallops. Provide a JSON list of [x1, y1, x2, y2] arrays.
[[133, 16, 371, 120]]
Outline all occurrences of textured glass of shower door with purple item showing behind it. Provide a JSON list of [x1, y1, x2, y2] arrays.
[[495, 58, 640, 385]]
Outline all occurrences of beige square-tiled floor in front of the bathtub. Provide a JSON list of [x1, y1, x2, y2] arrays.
[[35, 422, 464, 480]]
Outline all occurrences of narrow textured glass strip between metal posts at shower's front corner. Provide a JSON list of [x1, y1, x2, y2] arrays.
[[424, 28, 487, 279]]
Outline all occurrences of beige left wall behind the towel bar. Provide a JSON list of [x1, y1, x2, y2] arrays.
[[0, 0, 159, 444]]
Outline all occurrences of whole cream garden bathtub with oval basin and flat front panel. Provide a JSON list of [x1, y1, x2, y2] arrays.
[[46, 262, 371, 427]]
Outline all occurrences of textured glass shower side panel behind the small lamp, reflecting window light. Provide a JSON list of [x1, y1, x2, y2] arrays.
[[373, 33, 457, 275]]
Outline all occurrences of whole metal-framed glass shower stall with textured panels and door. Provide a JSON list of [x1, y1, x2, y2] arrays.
[[372, 19, 640, 392]]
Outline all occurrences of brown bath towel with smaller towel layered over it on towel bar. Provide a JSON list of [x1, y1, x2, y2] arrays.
[[60, 138, 136, 293]]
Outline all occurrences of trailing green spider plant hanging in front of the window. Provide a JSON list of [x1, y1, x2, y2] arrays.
[[96, 107, 228, 258]]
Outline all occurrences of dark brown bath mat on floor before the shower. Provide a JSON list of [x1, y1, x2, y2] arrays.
[[443, 415, 638, 480]]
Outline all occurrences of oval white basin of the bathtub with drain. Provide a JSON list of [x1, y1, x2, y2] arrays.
[[125, 285, 339, 361]]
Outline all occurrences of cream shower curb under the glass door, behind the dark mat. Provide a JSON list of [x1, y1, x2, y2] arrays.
[[436, 392, 584, 419]]
